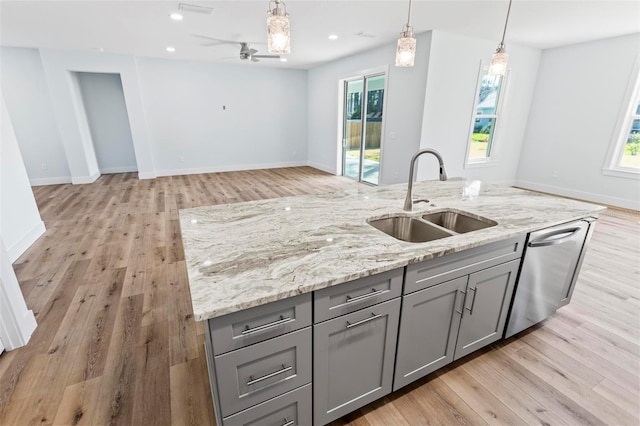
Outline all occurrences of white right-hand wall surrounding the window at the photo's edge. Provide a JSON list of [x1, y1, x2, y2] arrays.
[[517, 34, 640, 209]]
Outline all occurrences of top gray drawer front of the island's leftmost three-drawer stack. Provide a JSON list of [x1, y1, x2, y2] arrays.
[[209, 293, 311, 355]]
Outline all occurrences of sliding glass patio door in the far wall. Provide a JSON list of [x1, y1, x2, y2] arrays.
[[342, 74, 385, 185]]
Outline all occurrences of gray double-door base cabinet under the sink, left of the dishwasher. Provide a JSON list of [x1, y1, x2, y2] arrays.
[[393, 256, 520, 390]]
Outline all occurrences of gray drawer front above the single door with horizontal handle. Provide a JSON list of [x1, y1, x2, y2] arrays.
[[313, 268, 404, 323]]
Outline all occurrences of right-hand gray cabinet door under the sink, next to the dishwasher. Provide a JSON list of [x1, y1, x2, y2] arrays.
[[455, 259, 520, 359]]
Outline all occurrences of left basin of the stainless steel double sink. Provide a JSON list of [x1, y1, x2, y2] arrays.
[[367, 216, 454, 243]]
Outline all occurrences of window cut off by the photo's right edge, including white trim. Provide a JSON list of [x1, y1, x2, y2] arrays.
[[603, 64, 640, 178]]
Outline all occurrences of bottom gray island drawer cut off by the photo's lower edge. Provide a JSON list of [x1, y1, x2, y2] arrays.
[[222, 383, 312, 426]]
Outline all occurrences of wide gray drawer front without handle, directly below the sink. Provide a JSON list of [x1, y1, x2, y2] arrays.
[[404, 235, 526, 294]]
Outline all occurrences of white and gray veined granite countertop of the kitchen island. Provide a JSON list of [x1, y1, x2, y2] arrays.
[[180, 179, 605, 321]]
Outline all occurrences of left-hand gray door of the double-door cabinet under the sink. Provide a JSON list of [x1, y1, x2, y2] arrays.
[[393, 276, 468, 390]]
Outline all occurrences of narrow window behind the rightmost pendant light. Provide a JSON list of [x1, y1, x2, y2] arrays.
[[465, 66, 506, 166]]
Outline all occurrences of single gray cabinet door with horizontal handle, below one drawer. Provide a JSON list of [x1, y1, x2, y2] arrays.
[[313, 298, 400, 425]]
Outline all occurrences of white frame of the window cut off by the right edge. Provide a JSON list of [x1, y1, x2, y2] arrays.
[[602, 55, 640, 179]]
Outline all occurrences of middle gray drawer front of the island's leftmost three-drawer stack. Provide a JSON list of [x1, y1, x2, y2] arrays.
[[214, 327, 312, 417]]
